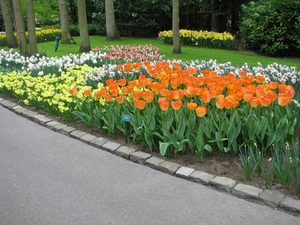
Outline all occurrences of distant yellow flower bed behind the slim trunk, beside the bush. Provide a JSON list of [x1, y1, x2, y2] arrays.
[[158, 29, 236, 49]]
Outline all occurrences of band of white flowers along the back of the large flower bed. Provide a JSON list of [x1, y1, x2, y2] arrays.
[[0, 48, 300, 84]]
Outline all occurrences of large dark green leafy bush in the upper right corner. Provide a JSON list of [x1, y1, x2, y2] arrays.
[[239, 0, 300, 55]]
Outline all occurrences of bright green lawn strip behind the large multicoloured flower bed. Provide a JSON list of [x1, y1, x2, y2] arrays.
[[14, 36, 300, 69]]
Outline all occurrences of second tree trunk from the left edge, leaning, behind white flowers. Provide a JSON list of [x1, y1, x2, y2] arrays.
[[13, 0, 28, 56]]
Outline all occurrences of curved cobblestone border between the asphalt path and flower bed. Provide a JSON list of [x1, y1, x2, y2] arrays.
[[0, 98, 300, 216]]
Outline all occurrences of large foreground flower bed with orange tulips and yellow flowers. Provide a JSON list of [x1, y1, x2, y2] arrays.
[[0, 46, 300, 193]]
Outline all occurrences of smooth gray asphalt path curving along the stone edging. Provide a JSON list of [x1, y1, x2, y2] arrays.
[[0, 106, 300, 225]]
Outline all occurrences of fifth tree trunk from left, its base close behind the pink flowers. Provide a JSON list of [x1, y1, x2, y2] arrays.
[[77, 0, 91, 52]]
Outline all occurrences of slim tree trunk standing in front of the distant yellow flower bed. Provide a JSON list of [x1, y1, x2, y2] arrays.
[[172, 0, 181, 54]]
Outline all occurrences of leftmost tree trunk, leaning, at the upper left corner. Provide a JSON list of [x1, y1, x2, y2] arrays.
[[0, 0, 18, 48]]
